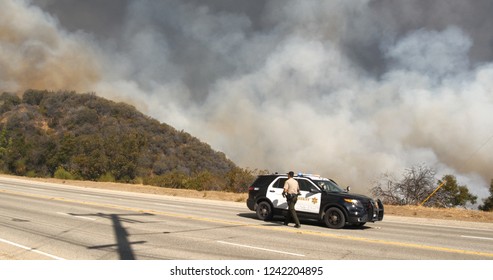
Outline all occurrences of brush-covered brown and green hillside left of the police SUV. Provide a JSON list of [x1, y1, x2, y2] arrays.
[[0, 90, 252, 191]]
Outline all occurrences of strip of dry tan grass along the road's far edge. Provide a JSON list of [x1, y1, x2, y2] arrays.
[[1, 175, 493, 223]]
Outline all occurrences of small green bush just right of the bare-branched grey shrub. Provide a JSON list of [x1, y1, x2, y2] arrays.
[[425, 175, 478, 208]]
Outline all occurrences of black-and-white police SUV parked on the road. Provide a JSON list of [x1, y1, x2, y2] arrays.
[[247, 173, 384, 229]]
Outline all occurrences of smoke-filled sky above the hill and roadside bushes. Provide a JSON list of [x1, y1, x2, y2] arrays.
[[0, 0, 493, 199]]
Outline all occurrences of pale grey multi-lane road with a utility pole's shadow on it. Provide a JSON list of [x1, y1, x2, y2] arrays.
[[0, 177, 493, 260]]
